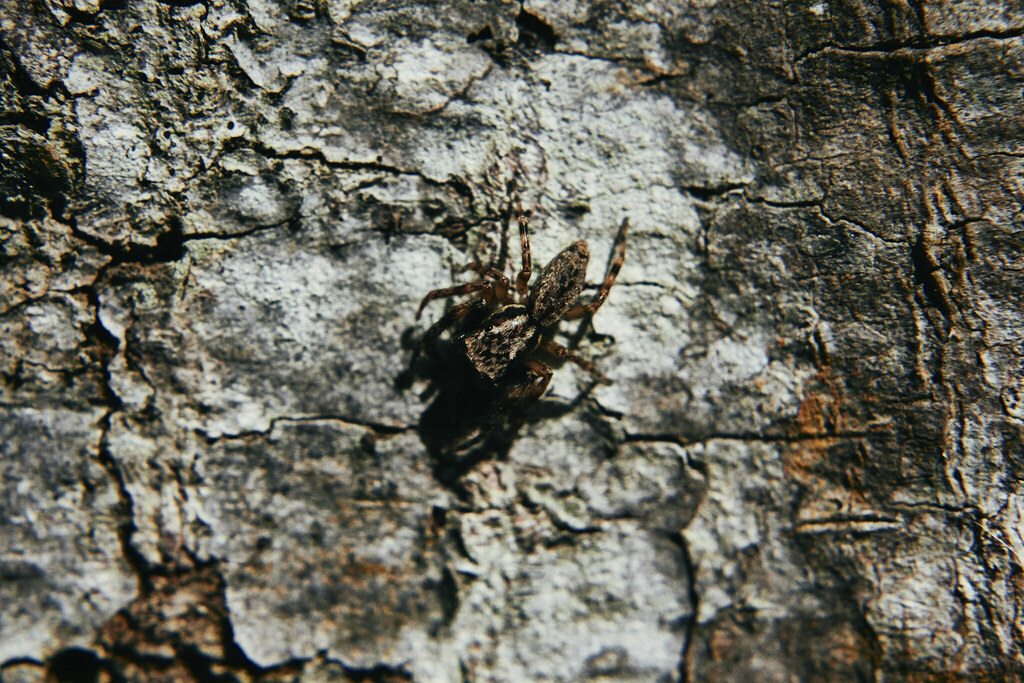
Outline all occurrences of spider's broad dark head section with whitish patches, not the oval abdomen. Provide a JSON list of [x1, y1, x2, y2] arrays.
[[460, 304, 540, 384]]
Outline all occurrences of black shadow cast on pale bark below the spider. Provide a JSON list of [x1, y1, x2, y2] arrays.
[[396, 318, 593, 494]]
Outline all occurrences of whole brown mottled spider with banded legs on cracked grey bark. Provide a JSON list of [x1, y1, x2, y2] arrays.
[[416, 195, 629, 400]]
